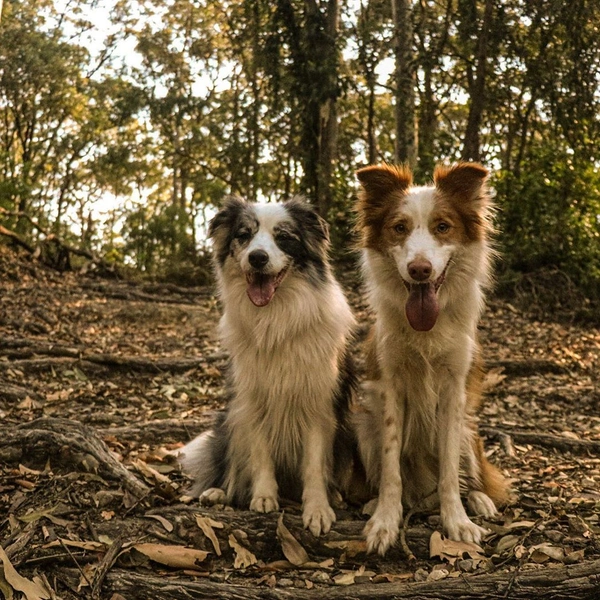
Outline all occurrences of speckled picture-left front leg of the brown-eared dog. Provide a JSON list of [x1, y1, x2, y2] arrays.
[[364, 385, 405, 556]]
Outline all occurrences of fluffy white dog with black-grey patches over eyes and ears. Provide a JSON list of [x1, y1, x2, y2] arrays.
[[181, 197, 355, 535]]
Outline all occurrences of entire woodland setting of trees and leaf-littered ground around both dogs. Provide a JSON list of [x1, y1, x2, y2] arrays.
[[0, 0, 600, 600]]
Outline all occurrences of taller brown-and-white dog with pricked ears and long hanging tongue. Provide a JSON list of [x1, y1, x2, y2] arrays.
[[357, 163, 507, 554]]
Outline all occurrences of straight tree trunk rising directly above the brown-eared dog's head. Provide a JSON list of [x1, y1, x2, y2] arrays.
[[392, 0, 417, 167]]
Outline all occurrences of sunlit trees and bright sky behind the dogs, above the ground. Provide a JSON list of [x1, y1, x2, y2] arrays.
[[0, 0, 600, 308]]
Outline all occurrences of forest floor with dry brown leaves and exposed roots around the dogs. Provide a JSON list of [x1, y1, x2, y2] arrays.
[[0, 246, 600, 600]]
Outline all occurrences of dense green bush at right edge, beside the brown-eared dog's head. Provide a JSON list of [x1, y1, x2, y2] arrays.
[[497, 143, 600, 297]]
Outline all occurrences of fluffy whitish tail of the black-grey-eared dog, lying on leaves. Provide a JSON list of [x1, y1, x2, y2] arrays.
[[179, 414, 228, 497]]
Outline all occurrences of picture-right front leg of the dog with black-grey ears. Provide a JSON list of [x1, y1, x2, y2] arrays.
[[302, 426, 335, 536]]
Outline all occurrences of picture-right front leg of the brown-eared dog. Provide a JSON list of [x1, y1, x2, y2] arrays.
[[438, 373, 486, 543]]
